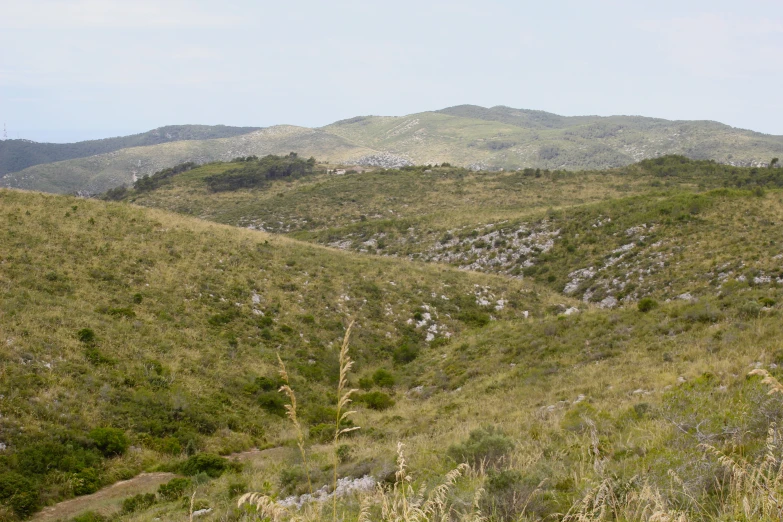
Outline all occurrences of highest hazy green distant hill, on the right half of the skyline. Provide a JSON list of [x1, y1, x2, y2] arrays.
[[324, 105, 783, 170]]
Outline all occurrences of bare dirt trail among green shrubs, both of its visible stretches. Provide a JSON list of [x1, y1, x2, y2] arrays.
[[32, 447, 291, 522]]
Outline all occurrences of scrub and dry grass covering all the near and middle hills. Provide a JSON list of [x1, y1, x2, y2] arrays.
[[0, 152, 783, 521]]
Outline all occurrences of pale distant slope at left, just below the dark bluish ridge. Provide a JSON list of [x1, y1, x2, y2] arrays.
[[0, 126, 373, 194]]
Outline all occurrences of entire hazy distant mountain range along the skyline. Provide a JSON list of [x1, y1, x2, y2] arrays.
[[0, 105, 783, 193]]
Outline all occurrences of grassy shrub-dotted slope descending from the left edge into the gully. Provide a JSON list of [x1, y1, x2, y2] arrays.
[[0, 191, 548, 516]]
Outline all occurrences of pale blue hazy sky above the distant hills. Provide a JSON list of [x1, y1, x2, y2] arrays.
[[0, 0, 783, 142]]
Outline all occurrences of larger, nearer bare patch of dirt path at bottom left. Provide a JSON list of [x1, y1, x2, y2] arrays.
[[32, 473, 176, 521]]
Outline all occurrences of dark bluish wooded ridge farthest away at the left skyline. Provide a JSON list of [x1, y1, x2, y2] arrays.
[[0, 125, 259, 177]]
